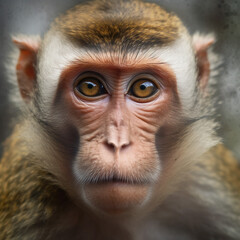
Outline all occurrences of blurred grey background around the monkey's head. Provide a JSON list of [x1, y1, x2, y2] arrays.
[[0, 0, 240, 160]]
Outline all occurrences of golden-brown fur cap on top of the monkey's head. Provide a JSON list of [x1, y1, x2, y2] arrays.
[[54, 0, 183, 50]]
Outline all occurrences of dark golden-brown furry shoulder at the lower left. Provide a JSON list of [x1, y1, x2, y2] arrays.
[[0, 133, 69, 239]]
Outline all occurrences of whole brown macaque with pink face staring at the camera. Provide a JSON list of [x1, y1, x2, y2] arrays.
[[0, 0, 240, 240]]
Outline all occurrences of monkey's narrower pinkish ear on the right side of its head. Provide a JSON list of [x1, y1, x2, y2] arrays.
[[193, 33, 215, 89]]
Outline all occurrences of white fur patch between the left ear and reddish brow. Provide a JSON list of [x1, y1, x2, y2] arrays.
[[37, 31, 86, 110]]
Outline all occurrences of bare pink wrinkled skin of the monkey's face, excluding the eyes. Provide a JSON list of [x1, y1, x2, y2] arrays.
[[55, 55, 178, 213]]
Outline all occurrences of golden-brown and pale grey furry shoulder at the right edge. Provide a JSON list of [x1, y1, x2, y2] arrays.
[[170, 144, 240, 239]]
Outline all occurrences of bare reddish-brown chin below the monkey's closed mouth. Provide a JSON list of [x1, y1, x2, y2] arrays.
[[83, 182, 150, 215]]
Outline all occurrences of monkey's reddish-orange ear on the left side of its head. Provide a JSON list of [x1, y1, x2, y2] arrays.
[[12, 36, 40, 102]]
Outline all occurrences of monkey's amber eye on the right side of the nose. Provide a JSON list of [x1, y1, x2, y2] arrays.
[[128, 79, 158, 98]]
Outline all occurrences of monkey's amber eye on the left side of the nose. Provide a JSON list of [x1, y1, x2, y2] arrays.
[[75, 77, 107, 97]]
